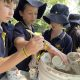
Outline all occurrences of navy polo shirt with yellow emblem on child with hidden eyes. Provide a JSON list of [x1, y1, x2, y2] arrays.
[[43, 30, 73, 54]]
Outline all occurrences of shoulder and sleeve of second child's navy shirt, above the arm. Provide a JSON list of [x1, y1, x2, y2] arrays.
[[13, 22, 34, 41]]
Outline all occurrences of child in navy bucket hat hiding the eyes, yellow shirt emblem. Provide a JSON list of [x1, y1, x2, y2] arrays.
[[43, 4, 72, 54]]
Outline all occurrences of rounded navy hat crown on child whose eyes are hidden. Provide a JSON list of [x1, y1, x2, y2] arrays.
[[50, 4, 69, 17]]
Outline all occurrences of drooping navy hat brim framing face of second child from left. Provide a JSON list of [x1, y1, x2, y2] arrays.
[[13, 0, 47, 21]]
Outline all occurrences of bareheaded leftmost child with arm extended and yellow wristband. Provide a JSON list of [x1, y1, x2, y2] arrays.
[[0, 0, 44, 77]]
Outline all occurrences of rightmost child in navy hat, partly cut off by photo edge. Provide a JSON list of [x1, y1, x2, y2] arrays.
[[67, 14, 80, 51]]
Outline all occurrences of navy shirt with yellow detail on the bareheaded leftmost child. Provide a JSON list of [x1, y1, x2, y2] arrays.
[[0, 23, 14, 79]]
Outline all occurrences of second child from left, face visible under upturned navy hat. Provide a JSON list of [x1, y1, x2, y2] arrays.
[[12, 0, 47, 71]]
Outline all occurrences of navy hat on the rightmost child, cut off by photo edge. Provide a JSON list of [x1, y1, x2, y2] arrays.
[[69, 14, 80, 25]]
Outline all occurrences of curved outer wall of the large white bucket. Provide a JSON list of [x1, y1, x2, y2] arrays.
[[39, 59, 80, 80]]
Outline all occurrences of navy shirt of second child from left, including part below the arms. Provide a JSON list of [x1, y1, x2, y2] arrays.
[[13, 22, 34, 71]]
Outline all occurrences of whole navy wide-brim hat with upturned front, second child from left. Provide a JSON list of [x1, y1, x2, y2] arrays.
[[13, 0, 47, 21]]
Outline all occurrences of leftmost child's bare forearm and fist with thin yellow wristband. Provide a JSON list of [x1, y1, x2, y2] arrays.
[[0, 36, 44, 73]]
